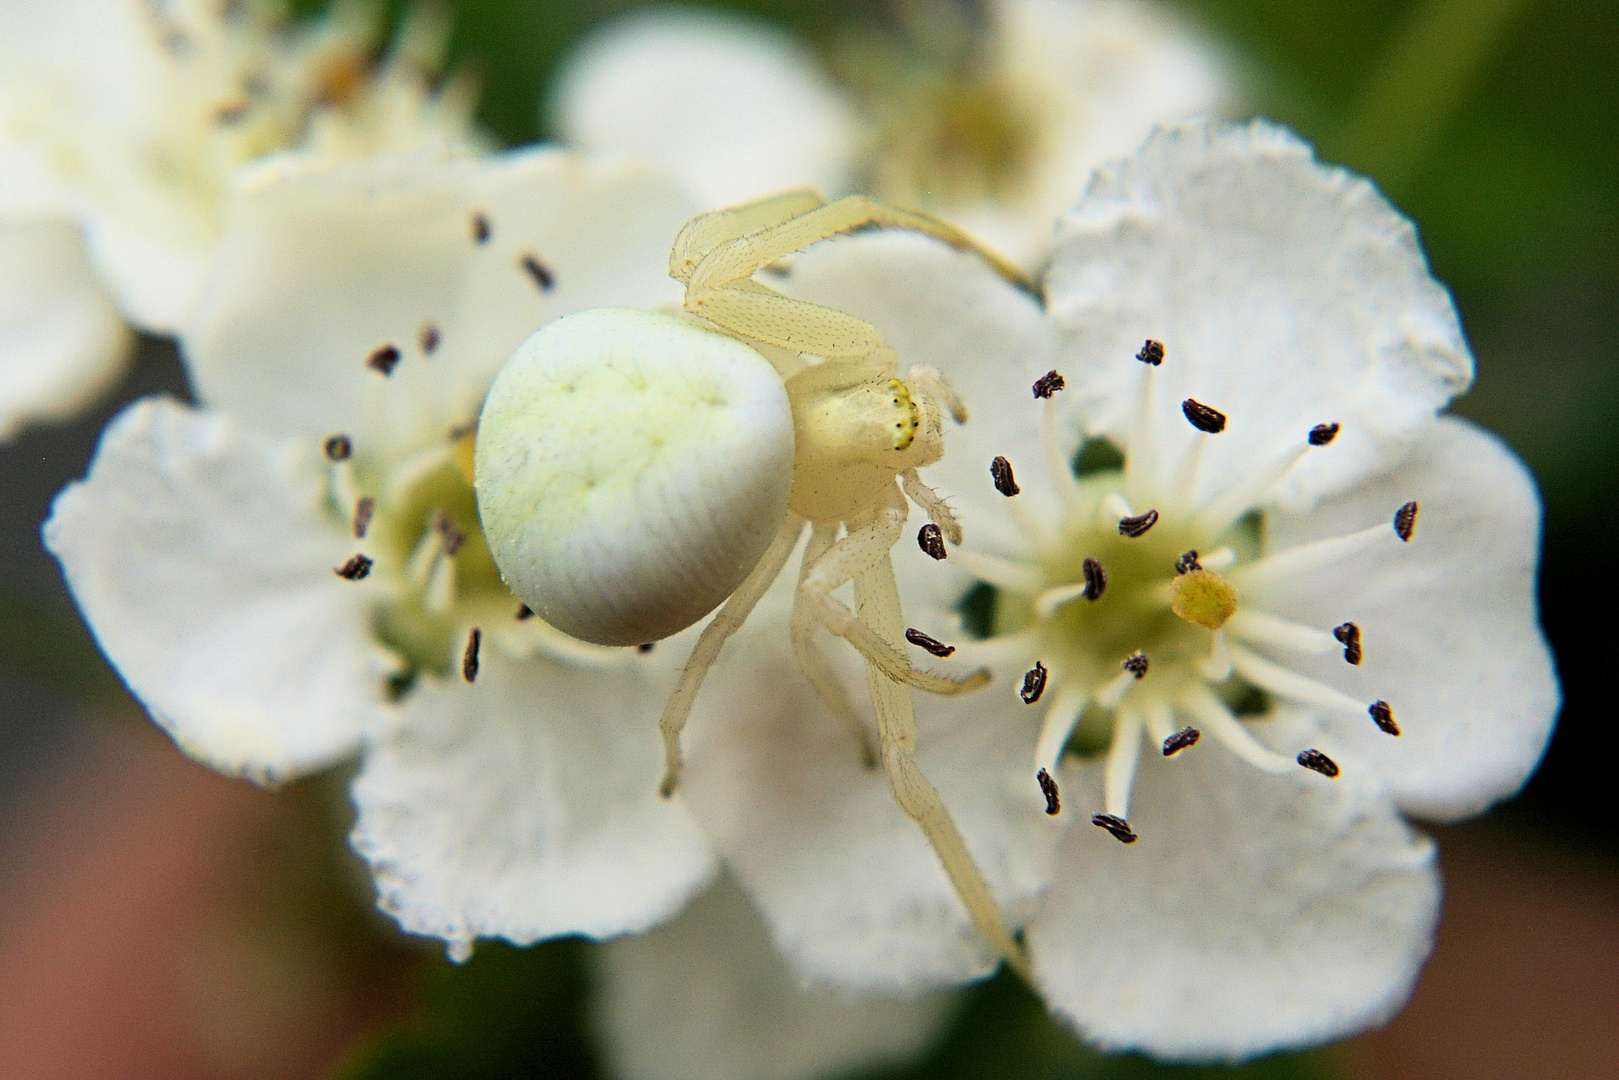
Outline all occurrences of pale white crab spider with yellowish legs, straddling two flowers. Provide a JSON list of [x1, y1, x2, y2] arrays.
[[474, 189, 1025, 970]]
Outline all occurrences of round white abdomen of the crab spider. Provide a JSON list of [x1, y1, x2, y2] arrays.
[[473, 308, 793, 644]]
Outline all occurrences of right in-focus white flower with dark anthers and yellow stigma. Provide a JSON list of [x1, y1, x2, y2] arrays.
[[722, 123, 1559, 1059]]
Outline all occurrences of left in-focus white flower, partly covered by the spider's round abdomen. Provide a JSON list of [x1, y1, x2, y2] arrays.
[[45, 149, 714, 955]]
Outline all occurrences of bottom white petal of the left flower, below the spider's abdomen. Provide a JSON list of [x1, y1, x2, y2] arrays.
[[351, 649, 714, 959]]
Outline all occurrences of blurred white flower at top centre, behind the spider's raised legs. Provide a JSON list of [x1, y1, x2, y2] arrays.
[[552, 0, 1232, 266]]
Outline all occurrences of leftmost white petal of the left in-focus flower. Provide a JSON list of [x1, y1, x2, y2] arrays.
[[44, 398, 387, 782]]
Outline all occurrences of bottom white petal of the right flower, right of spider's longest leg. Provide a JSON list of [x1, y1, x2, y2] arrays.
[[1028, 738, 1439, 1061]]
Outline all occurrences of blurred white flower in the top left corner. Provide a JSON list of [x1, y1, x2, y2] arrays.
[[0, 0, 476, 437]]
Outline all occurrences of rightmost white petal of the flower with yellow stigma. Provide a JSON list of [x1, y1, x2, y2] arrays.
[[1251, 418, 1559, 821]]
